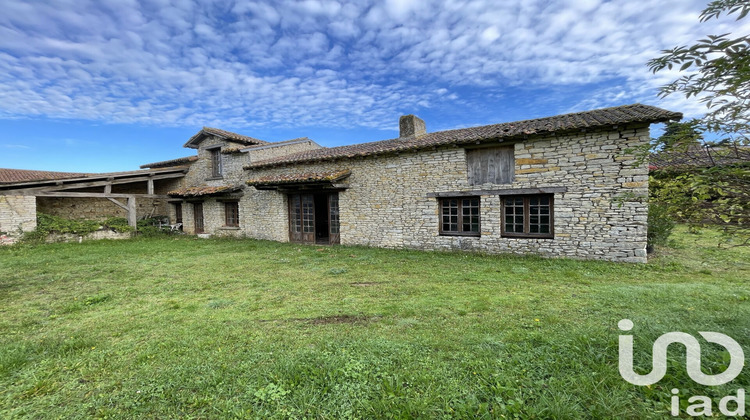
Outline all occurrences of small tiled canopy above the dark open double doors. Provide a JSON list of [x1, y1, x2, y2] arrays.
[[247, 169, 352, 190]]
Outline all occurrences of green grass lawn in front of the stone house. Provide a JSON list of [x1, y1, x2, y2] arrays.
[[0, 229, 750, 419]]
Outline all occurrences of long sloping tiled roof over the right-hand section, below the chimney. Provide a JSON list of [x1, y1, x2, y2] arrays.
[[245, 104, 682, 169]]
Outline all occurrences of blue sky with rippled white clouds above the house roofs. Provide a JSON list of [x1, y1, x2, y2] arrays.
[[0, 0, 750, 172]]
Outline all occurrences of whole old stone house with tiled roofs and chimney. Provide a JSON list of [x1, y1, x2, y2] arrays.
[[0, 104, 682, 262]]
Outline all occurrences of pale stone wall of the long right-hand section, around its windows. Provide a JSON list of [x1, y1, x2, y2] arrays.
[[241, 125, 649, 262]]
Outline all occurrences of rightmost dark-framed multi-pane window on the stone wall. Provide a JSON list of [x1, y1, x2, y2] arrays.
[[502, 194, 554, 238]]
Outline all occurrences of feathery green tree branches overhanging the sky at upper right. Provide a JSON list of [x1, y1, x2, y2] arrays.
[[648, 0, 750, 144]]
